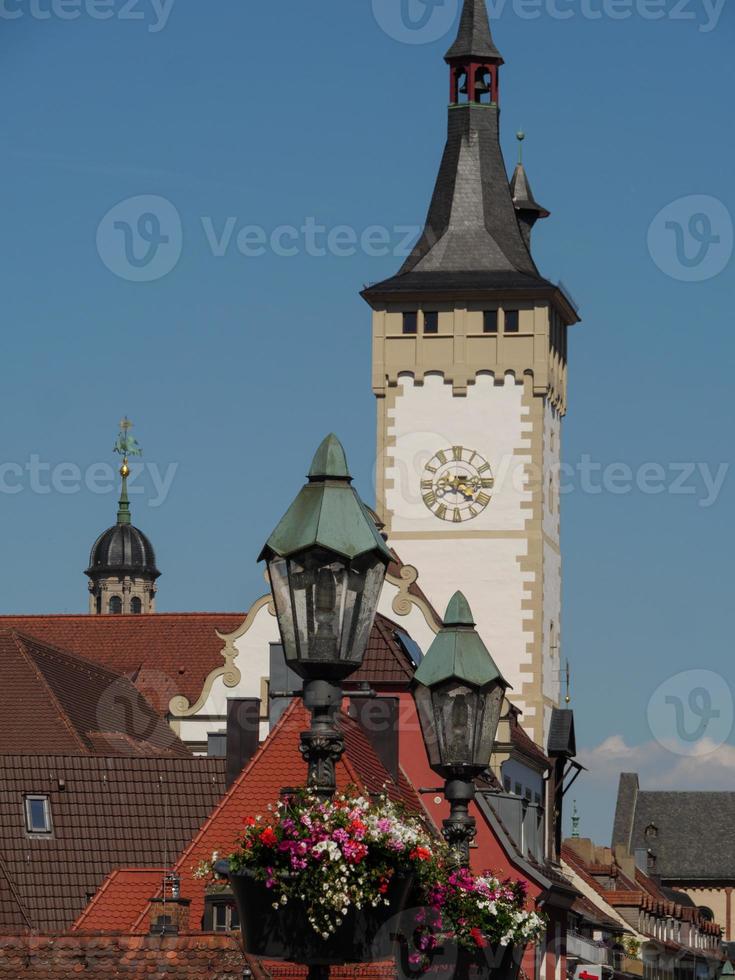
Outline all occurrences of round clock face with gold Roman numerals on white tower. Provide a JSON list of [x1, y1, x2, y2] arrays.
[[421, 446, 495, 524]]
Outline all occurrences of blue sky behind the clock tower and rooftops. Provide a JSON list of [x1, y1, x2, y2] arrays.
[[0, 0, 735, 839]]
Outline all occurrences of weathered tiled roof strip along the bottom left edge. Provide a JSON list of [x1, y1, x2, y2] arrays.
[[0, 934, 245, 980]]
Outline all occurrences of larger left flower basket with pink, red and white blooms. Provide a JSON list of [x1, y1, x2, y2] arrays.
[[218, 790, 437, 965]]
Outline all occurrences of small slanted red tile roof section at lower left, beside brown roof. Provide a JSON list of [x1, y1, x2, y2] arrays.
[[72, 868, 165, 934]]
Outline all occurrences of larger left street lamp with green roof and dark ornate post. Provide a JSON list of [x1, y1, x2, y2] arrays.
[[260, 435, 392, 797]]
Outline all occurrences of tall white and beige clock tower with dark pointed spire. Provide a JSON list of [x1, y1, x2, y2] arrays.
[[363, 0, 579, 745]]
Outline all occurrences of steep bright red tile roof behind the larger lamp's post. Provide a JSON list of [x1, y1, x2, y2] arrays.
[[129, 699, 434, 932]]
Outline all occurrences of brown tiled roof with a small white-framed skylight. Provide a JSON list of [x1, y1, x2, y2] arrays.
[[0, 755, 225, 934]]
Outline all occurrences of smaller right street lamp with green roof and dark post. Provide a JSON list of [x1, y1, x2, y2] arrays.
[[413, 592, 510, 867]]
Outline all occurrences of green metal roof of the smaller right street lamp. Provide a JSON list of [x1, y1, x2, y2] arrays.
[[414, 592, 510, 688]]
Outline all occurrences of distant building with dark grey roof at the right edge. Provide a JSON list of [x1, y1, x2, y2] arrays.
[[612, 772, 735, 941]]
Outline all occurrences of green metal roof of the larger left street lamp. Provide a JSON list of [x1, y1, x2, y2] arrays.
[[260, 435, 393, 562]]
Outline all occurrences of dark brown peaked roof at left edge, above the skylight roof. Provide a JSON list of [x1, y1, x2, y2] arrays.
[[0, 630, 189, 756]]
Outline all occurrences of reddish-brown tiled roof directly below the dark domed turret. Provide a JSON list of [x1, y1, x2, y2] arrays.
[[0, 613, 245, 713]]
